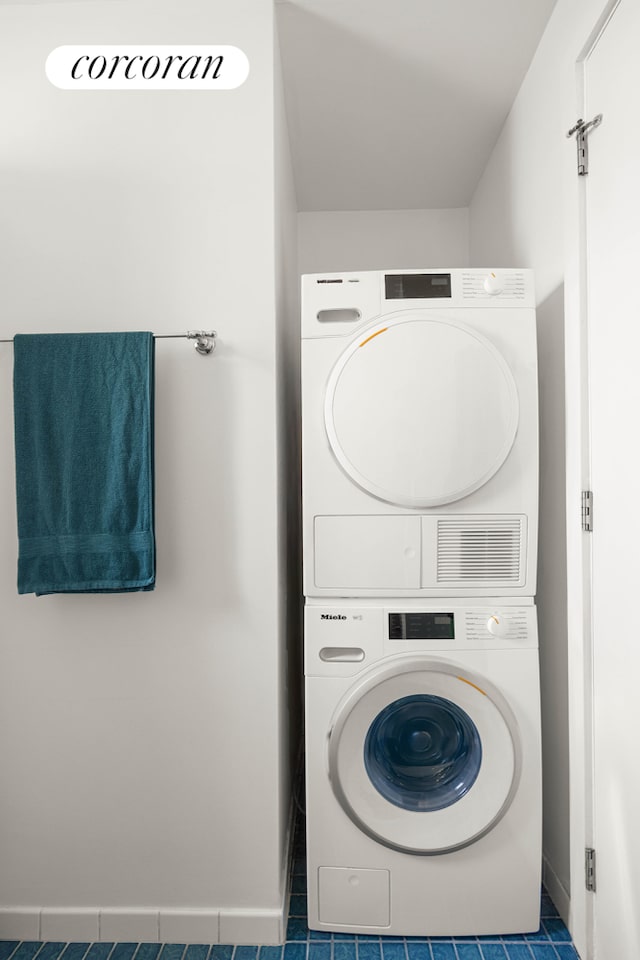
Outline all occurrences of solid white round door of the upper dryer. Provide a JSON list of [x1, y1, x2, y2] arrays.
[[324, 311, 519, 507]]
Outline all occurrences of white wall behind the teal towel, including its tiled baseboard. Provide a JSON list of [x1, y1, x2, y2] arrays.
[[0, 0, 294, 943]]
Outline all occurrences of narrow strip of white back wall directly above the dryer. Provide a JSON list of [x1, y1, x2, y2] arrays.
[[298, 208, 469, 273]]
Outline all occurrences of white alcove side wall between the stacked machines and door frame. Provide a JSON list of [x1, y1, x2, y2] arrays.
[[469, 0, 605, 928]]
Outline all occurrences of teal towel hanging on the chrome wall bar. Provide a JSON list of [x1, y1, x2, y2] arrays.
[[13, 333, 155, 595]]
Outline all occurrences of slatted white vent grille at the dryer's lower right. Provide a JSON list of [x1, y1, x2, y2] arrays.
[[437, 517, 522, 584]]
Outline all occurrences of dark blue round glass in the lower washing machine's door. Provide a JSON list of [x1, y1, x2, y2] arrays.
[[364, 694, 482, 811]]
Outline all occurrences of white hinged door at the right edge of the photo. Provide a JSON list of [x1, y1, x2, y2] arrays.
[[584, 0, 640, 960]]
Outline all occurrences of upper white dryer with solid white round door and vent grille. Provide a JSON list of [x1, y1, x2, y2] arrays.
[[302, 270, 538, 597]]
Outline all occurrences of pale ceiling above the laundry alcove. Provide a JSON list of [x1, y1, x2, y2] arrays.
[[276, 0, 556, 211]]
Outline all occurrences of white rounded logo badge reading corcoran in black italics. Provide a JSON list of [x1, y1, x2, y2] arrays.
[[45, 44, 249, 90]]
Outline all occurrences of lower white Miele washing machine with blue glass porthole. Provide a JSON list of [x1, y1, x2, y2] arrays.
[[305, 598, 542, 936]]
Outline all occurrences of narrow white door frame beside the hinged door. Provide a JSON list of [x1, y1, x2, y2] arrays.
[[565, 0, 622, 960]]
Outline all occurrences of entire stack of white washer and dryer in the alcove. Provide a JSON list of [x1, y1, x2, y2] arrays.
[[302, 270, 541, 936]]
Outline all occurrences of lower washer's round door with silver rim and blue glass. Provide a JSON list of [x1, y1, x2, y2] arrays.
[[328, 657, 521, 855]]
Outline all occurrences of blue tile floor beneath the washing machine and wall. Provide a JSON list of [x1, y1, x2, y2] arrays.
[[0, 816, 578, 960]]
